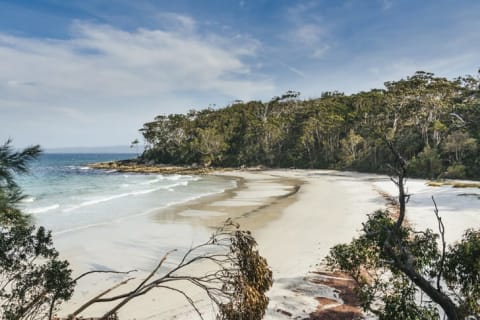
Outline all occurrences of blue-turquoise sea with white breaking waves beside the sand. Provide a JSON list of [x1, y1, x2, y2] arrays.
[[18, 154, 234, 234]]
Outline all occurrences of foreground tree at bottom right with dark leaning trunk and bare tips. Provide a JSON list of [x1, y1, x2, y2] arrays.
[[326, 141, 480, 320]]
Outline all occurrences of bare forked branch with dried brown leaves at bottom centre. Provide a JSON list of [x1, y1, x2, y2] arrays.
[[64, 220, 272, 320]]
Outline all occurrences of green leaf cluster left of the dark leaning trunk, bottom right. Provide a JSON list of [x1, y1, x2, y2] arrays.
[[325, 211, 440, 319]]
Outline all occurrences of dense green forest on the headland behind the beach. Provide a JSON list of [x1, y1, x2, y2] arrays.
[[140, 71, 480, 179]]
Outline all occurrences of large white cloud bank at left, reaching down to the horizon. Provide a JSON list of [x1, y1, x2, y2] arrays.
[[0, 20, 275, 147]]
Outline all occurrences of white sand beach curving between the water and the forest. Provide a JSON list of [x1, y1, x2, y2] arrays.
[[60, 170, 480, 320]]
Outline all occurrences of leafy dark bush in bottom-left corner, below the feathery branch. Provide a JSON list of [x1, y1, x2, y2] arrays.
[[0, 226, 74, 319]]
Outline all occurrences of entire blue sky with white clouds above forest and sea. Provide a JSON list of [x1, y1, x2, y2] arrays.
[[0, 0, 480, 148]]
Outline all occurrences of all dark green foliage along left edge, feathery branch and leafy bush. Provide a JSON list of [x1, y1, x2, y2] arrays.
[[0, 141, 74, 320]]
